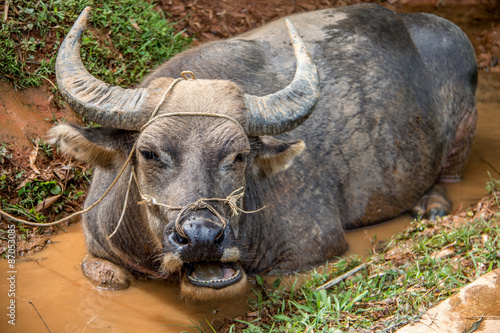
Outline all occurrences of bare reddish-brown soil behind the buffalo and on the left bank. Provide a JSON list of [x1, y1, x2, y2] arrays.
[[0, 0, 500, 262]]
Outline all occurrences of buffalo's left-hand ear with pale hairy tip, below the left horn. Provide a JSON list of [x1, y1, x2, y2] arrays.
[[48, 124, 135, 169]]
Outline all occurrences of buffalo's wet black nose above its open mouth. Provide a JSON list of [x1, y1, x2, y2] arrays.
[[171, 218, 224, 262]]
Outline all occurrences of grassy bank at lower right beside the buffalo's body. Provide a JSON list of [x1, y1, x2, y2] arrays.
[[222, 187, 500, 332]]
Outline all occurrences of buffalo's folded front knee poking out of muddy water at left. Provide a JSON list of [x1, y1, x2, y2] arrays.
[[82, 256, 130, 290]]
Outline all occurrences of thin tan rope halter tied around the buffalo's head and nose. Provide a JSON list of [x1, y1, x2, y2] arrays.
[[0, 71, 265, 231]]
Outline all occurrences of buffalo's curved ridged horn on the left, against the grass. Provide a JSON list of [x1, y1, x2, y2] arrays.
[[56, 7, 149, 130]]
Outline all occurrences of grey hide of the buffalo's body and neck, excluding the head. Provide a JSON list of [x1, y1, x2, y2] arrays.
[[50, 5, 477, 296]]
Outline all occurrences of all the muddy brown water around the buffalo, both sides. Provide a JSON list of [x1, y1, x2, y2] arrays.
[[0, 65, 500, 332]]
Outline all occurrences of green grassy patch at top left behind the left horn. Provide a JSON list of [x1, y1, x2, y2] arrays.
[[0, 0, 190, 88]]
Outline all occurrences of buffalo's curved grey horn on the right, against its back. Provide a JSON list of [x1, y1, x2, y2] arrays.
[[244, 19, 320, 136]]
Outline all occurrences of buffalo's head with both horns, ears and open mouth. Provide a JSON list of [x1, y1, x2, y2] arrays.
[[47, 8, 319, 299]]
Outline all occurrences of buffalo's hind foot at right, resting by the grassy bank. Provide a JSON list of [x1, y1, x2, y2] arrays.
[[412, 184, 451, 220]]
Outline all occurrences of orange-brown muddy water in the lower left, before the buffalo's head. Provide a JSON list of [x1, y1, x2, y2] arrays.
[[0, 225, 246, 332]]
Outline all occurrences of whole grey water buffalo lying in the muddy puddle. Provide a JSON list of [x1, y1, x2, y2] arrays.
[[50, 5, 477, 299]]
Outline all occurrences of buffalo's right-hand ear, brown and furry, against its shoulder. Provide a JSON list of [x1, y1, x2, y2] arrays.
[[252, 136, 306, 177]]
